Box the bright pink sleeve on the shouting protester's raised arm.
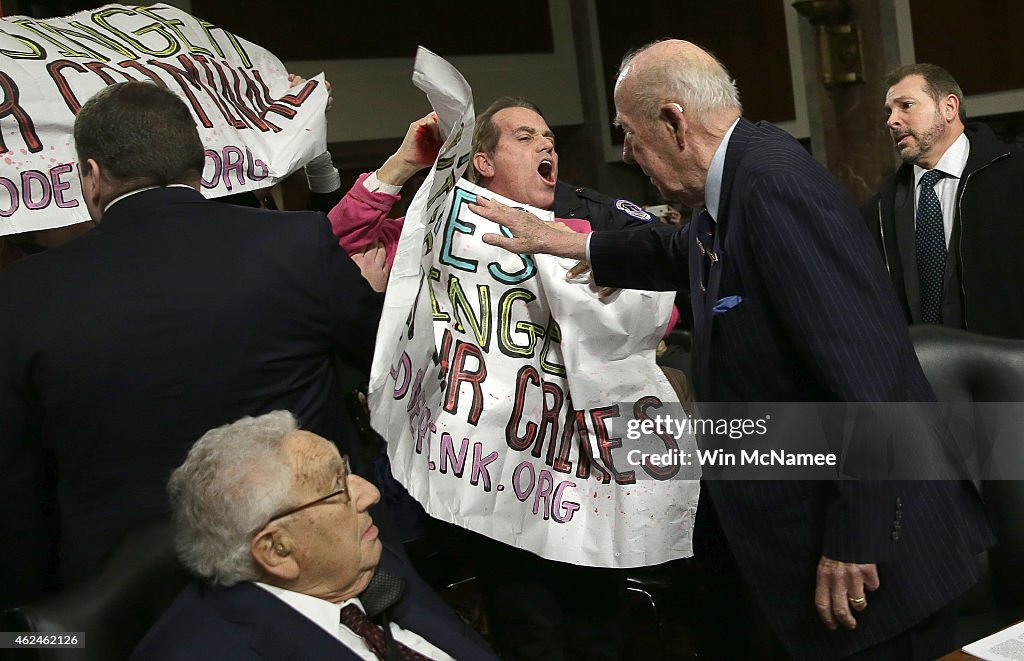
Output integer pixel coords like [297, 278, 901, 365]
[327, 172, 404, 267]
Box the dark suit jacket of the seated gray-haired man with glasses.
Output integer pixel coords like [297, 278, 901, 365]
[131, 545, 497, 661]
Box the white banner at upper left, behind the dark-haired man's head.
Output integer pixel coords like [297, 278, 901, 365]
[0, 4, 328, 235]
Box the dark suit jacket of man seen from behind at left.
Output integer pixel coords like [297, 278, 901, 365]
[0, 187, 382, 604]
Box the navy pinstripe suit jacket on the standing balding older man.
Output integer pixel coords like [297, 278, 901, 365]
[591, 120, 990, 659]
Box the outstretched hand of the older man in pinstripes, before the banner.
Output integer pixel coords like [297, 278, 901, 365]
[469, 196, 588, 261]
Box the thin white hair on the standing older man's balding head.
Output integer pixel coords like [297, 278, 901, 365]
[615, 40, 742, 121]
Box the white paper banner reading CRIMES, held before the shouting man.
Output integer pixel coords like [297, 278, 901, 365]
[370, 49, 699, 567]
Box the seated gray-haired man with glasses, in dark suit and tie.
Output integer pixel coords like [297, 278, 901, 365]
[132, 411, 495, 661]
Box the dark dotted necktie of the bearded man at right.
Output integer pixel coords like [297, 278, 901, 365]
[915, 170, 946, 323]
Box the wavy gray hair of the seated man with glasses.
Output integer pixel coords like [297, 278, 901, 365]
[167, 410, 298, 585]
